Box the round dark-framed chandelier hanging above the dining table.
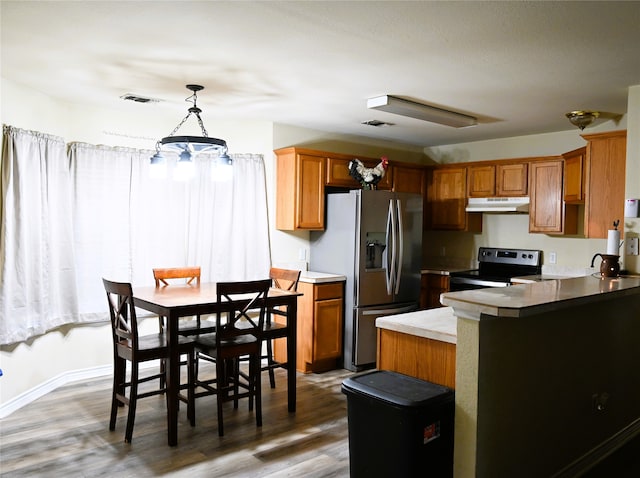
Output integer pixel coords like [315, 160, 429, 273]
[151, 85, 231, 165]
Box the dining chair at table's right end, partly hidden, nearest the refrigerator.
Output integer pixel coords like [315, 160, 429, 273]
[262, 267, 300, 388]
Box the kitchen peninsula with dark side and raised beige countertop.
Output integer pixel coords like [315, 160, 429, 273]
[440, 276, 640, 478]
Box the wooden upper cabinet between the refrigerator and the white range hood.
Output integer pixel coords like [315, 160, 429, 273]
[426, 167, 482, 231]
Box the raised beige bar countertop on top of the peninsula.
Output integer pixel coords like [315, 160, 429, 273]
[441, 275, 640, 320]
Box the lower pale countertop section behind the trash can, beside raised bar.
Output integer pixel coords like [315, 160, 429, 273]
[376, 307, 457, 344]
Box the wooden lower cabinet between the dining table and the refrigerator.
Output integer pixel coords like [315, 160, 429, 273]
[274, 282, 344, 373]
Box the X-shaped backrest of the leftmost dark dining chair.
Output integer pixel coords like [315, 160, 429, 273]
[102, 279, 138, 350]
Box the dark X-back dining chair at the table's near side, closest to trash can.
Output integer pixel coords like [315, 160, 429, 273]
[195, 279, 271, 436]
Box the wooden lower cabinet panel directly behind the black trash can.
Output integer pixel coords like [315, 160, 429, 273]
[377, 329, 456, 388]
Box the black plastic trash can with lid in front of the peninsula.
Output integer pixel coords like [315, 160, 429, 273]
[342, 370, 455, 478]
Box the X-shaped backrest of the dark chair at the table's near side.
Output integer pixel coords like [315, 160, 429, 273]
[216, 279, 271, 346]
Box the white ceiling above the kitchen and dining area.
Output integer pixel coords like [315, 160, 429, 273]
[0, 0, 640, 146]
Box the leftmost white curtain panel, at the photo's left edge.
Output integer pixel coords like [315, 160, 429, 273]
[0, 126, 78, 344]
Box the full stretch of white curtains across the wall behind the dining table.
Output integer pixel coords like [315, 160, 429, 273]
[0, 128, 271, 344]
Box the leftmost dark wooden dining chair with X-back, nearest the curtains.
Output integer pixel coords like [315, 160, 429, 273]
[102, 279, 195, 443]
